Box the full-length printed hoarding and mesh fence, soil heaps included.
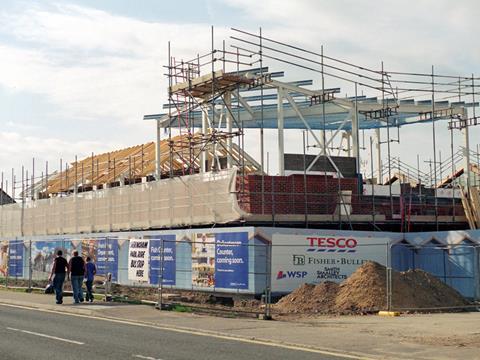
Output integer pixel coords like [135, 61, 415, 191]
[0, 238, 480, 319]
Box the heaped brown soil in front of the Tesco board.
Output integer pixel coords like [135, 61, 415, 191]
[275, 261, 469, 314]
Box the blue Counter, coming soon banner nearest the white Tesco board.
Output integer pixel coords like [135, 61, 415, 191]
[215, 232, 248, 289]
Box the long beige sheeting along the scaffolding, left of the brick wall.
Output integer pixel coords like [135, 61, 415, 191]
[0, 169, 244, 237]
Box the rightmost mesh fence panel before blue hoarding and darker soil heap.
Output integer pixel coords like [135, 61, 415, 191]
[388, 240, 480, 312]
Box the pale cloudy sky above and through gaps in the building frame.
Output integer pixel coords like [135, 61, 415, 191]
[0, 0, 480, 186]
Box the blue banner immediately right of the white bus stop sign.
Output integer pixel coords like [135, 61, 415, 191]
[149, 235, 177, 285]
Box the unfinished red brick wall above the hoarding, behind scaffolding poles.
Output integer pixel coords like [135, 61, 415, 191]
[237, 174, 464, 219]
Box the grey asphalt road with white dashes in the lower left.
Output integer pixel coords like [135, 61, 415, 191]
[0, 305, 344, 360]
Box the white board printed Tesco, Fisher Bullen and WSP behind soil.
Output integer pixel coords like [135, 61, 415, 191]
[271, 232, 389, 292]
